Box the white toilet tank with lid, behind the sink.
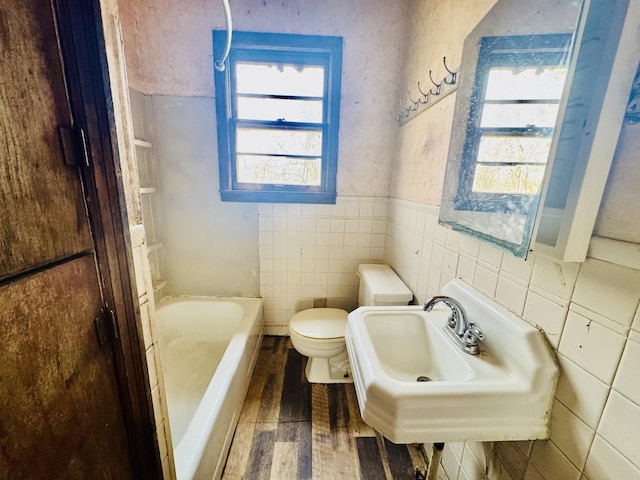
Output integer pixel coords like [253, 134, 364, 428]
[358, 264, 413, 306]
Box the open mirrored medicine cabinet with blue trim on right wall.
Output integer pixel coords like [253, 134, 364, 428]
[439, 0, 640, 262]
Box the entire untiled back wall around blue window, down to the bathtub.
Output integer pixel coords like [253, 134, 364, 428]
[118, 0, 408, 296]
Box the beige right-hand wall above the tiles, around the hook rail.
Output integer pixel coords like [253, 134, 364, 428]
[389, 0, 496, 205]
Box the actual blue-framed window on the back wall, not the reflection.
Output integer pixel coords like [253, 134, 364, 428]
[213, 30, 342, 203]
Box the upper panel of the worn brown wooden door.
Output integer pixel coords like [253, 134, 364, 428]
[0, 0, 92, 278]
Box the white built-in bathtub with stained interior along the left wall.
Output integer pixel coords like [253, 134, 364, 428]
[157, 297, 263, 480]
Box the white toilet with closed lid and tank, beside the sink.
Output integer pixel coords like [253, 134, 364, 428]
[289, 264, 413, 383]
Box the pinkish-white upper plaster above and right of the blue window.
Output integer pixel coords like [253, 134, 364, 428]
[118, 0, 408, 196]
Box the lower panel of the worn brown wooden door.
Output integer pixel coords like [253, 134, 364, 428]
[0, 255, 131, 479]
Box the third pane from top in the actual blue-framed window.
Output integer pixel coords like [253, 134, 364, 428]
[236, 128, 322, 157]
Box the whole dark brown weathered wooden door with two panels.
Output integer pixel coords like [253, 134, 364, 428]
[0, 0, 133, 479]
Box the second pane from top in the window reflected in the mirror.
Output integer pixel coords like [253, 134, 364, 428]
[480, 103, 558, 128]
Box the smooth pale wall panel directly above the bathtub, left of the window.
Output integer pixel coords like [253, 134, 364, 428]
[151, 95, 260, 297]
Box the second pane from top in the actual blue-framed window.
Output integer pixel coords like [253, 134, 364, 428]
[237, 97, 323, 123]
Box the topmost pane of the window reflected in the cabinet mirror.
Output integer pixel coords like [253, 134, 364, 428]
[484, 66, 567, 100]
